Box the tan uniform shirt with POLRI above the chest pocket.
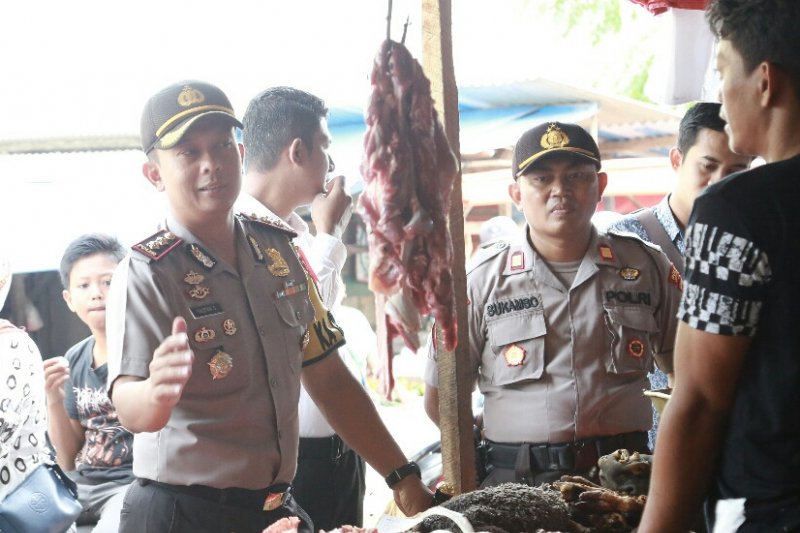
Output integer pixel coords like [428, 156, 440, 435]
[426, 229, 681, 444]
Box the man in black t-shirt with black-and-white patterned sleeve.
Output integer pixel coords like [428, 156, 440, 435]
[639, 0, 800, 532]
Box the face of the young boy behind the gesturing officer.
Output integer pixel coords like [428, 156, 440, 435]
[63, 253, 117, 334]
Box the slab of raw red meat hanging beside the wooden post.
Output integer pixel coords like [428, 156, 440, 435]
[359, 39, 458, 362]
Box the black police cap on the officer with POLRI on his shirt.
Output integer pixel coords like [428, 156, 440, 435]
[511, 122, 600, 179]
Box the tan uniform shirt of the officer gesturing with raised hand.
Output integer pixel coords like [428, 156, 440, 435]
[107, 214, 344, 489]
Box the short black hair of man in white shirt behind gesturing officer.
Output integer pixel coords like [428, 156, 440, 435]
[242, 87, 328, 172]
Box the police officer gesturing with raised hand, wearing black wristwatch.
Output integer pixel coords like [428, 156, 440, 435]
[107, 81, 431, 533]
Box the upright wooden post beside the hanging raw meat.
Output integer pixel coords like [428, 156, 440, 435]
[422, 0, 475, 494]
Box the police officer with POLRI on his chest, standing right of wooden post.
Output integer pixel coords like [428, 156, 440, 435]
[426, 122, 681, 486]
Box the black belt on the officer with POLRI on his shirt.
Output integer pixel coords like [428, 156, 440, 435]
[487, 431, 649, 472]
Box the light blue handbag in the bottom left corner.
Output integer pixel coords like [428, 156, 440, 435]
[0, 464, 81, 533]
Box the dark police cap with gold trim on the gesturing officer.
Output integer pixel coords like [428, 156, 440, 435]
[141, 80, 242, 153]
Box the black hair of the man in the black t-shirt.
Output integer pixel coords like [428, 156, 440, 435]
[706, 0, 800, 98]
